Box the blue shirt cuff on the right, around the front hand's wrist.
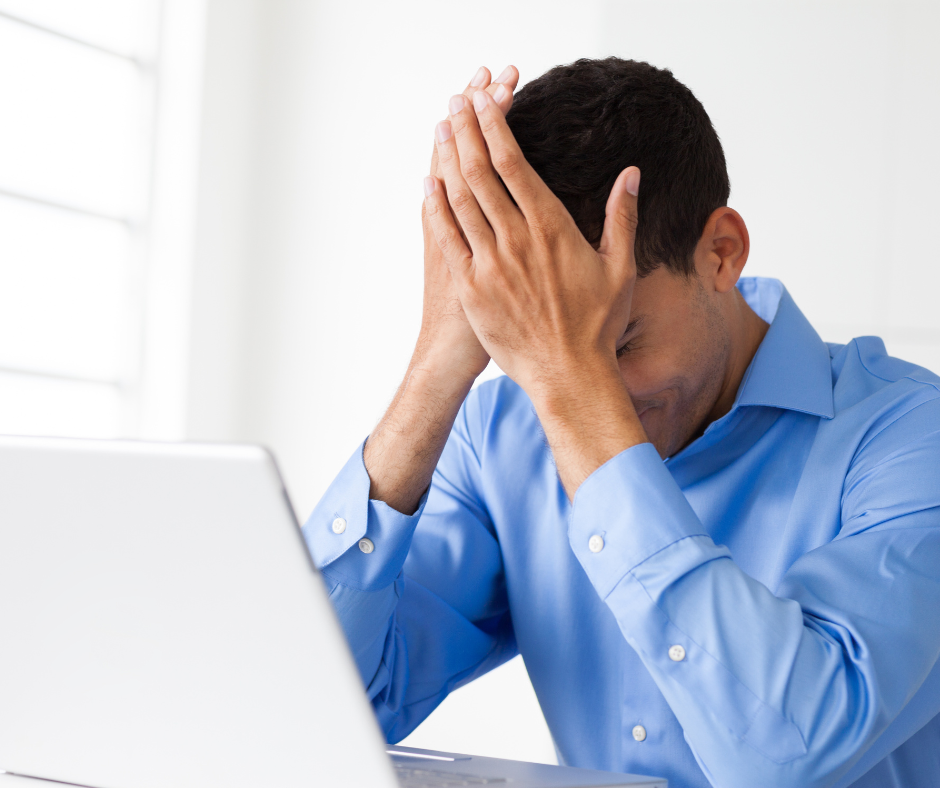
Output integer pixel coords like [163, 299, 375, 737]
[568, 443, 706, 599]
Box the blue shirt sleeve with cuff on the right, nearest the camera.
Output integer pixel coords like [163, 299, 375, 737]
[569, 400, 940, 788]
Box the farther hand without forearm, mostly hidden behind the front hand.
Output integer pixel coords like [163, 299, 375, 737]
[415, 66, 519, 383]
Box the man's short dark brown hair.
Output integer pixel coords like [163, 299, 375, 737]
[507, 57, 731, 276]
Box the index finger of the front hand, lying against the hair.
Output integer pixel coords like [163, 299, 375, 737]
[473, 86, 560, 218]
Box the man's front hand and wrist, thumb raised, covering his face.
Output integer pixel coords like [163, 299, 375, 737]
[425, 86, 647, 498]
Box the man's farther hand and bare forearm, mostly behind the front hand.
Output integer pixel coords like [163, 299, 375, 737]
[363, 66, 519, 514]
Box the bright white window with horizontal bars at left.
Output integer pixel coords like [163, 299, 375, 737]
[0, 0, 200, 438]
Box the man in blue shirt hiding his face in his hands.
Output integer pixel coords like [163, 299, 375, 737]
[304, 58, 940, 788]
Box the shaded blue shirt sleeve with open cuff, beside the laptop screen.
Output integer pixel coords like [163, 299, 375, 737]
[303, 392, 517, 742]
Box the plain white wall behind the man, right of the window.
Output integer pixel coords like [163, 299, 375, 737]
[189, 0, 940, 760]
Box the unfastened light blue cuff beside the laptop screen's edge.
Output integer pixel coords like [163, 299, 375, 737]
[302, 441, 428, 591]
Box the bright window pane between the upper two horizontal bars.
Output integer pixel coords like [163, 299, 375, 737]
[0, 16, 144, 216]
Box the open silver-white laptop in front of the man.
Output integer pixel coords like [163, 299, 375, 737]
[0, 437, 666, 788]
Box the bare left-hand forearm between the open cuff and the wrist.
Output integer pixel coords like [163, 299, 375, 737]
[364, 343, 474, 514]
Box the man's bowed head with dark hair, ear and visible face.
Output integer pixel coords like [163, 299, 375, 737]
[507, 58, 766, 456]
